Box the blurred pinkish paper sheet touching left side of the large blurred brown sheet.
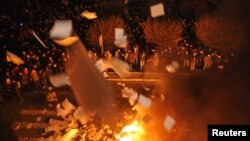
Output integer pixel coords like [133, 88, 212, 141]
[49, 73, 70, 87]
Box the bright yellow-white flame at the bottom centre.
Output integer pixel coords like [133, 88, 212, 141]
[116, 120, 144, 141]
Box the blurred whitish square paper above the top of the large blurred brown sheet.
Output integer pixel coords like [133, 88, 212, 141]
[50, 20, 73, 39]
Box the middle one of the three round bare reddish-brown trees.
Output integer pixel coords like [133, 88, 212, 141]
[141, 19, 183, 50]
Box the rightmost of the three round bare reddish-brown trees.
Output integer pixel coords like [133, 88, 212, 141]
[195, 15, 247, 51]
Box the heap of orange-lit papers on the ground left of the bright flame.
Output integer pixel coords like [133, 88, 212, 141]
[40, 99, 115, 141]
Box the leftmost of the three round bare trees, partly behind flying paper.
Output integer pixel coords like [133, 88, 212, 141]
[87, 16, 125, 50]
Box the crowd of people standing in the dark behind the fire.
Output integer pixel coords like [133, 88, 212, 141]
[0, 0, 232, 102]
